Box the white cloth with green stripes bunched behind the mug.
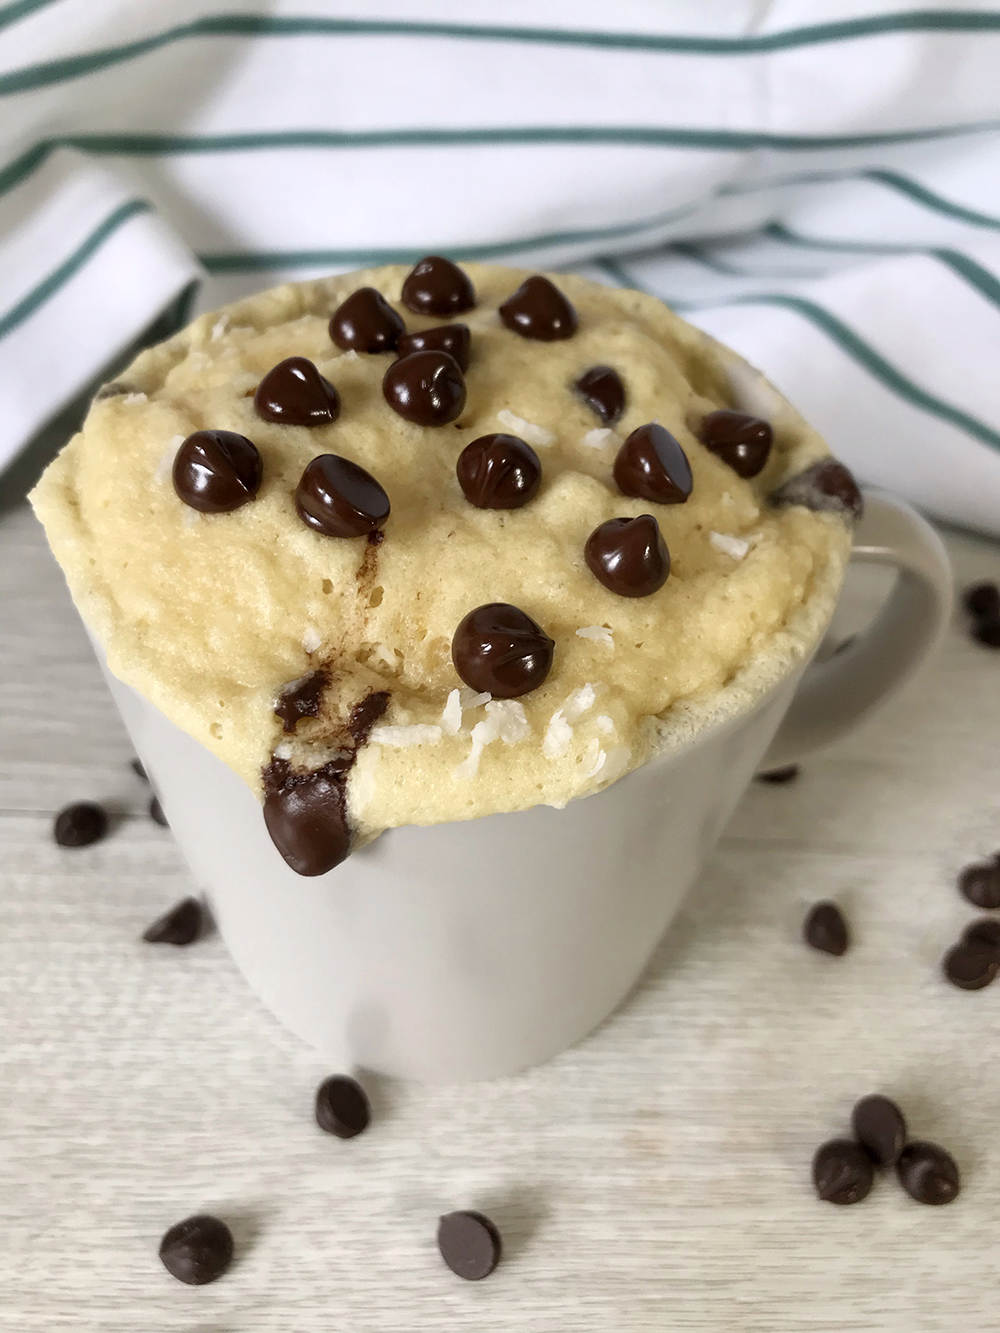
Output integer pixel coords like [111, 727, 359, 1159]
[0, 0, 1000, 535]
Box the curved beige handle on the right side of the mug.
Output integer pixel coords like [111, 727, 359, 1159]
[760, 491, 952, 772]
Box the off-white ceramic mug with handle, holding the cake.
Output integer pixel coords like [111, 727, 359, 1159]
[98, 495, 951, 1081]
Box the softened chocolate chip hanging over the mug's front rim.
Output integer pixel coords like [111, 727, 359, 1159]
[264, 760, 351, 876]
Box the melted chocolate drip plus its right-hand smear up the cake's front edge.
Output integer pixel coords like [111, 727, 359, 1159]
[263, 690, 389, 876]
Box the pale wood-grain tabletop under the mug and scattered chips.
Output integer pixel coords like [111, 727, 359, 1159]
[0, 508, 1000, 1333]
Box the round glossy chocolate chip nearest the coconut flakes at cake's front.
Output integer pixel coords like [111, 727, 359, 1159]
[452, 601, 556, 698]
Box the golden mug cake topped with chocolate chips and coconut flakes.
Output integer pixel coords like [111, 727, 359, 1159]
[32, 261, 855, 863]
